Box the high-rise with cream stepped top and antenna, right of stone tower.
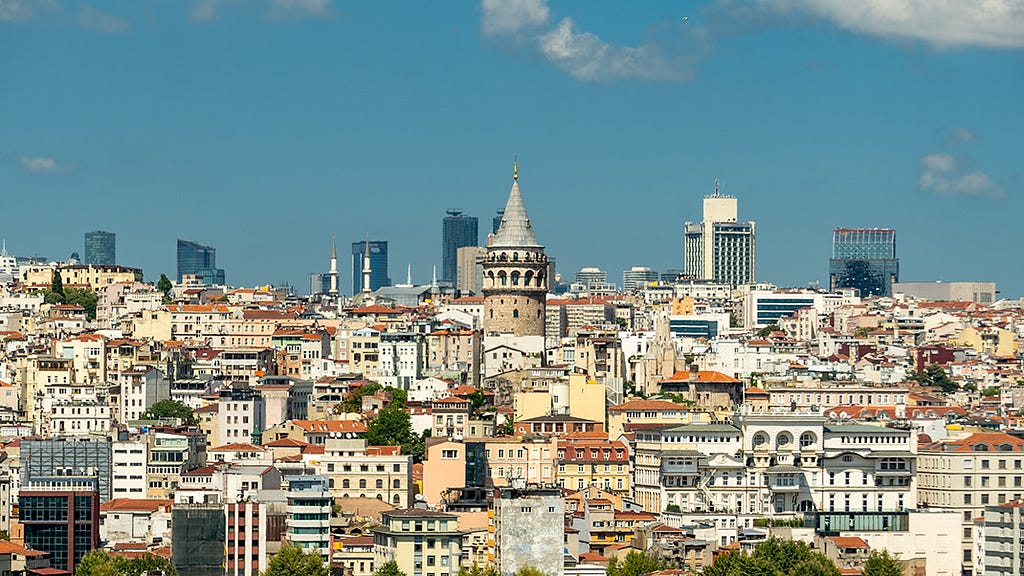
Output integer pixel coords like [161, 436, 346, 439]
[683, 178, 755, 287]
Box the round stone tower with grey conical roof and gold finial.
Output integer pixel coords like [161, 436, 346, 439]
[482, 158, 548, 337]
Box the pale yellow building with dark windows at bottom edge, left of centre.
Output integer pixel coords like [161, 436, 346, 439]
[374, 508, 463, 576]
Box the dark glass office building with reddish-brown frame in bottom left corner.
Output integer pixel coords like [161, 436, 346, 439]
[18, 476, 99, 574]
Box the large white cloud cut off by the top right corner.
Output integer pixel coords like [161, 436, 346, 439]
[759, 0, 1024, 48]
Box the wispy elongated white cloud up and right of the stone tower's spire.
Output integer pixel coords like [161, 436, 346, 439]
[539, 17, 688, 80]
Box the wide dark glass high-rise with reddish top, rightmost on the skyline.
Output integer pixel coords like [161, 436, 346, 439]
[828, 228, 899, 296]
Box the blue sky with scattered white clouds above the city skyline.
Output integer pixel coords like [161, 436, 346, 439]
[0, 0, 1024, 297]
